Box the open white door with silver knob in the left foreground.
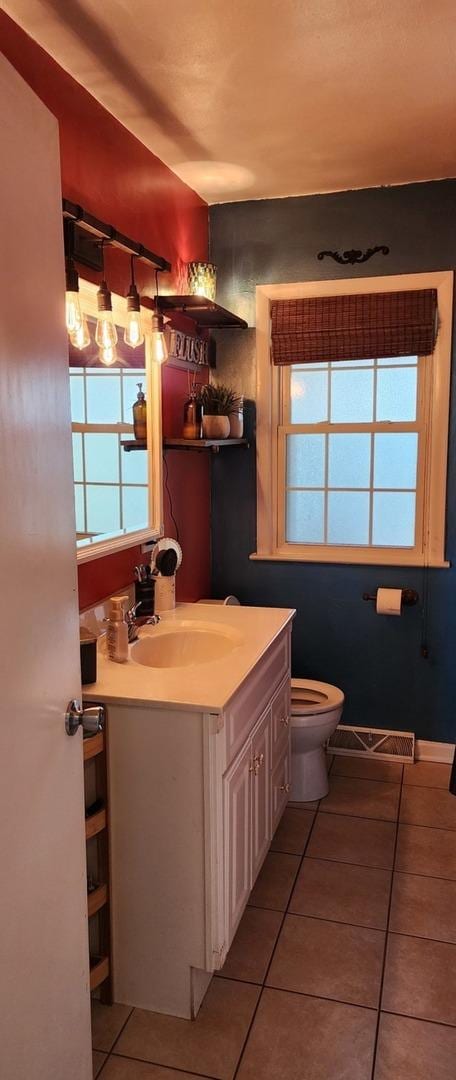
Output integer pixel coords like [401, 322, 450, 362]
[0, 56, 92, 1080]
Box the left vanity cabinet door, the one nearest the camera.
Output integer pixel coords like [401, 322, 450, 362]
[224, 742, 252, 946]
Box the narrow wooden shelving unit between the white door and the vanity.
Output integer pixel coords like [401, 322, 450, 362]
[82, 728, 112, 1004]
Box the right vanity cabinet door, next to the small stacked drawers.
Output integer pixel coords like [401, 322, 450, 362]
[251, 708, 271, 883]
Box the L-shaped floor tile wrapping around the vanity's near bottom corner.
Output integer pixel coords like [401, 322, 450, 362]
[116, 978, 260, 1080]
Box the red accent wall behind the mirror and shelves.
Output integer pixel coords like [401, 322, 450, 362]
[0, 11, 210, 608]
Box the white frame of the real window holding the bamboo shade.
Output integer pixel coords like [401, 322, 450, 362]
[250, 270, 453, 567]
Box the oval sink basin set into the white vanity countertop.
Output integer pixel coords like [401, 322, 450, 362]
[130, 623, 243, 667]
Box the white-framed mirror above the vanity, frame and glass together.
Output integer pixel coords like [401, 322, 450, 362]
[69, 282, 161, 561]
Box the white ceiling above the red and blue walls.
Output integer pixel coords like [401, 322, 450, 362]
[0, 0, 456, 202]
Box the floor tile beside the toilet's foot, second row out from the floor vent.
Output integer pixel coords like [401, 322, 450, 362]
[320, 777, 399, 821]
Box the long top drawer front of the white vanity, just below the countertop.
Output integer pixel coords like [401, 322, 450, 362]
[225, 629, 291, 766]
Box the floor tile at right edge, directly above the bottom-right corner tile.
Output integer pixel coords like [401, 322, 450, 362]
[381, 934, 456, 1025]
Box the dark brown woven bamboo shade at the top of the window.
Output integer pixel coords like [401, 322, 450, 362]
[271, 288, 437, 364]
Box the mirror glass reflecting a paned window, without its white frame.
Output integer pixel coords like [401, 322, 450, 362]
[69, 316, 149, 549]
